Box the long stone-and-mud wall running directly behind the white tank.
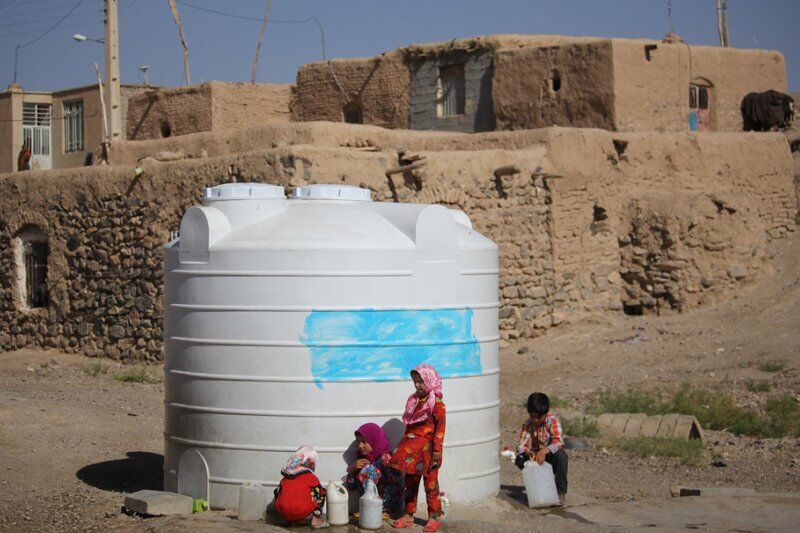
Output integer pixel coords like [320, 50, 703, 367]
[0, 123, 795, 359]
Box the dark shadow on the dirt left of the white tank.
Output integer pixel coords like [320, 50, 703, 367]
[75, 452, 164, 492]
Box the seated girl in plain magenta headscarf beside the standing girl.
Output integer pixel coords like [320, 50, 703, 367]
[344, 422, 403, 518]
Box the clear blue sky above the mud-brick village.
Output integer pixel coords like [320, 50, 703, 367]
[0, 0, 800, 91]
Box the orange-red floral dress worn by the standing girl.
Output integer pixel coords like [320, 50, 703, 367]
[389, 398, 446, 475]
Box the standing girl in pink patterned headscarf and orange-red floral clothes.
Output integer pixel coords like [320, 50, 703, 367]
[389, 364, 445, 532]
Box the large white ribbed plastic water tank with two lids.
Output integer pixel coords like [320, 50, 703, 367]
[164, 184, 500, 509]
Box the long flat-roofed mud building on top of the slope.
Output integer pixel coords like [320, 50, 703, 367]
[292, 35, 787, 132]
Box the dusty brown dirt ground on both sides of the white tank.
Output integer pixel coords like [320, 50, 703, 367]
[0, 233, 800, 531]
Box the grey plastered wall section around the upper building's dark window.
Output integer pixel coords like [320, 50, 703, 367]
[408, 50, 495, 132]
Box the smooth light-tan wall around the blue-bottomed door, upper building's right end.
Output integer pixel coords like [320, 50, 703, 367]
[611, 39, 787, 131]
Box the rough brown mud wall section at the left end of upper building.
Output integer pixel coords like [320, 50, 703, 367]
[291, 51, 410, 128]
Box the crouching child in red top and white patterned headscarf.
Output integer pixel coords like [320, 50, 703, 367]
[275, 446, 328, 529]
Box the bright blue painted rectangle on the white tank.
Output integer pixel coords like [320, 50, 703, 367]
[300, 309, 482, 386]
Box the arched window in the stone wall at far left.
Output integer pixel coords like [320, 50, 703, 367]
[16, 226, 50, 309]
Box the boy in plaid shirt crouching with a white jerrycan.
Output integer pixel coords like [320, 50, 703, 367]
[514, 392, 568, 506]
